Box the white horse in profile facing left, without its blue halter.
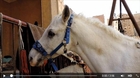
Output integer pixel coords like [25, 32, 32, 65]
[29, 5, 140, 73]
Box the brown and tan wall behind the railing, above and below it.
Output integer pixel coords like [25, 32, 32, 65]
[0, 0, 63, 56]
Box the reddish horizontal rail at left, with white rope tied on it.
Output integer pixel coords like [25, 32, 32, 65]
[3, 14, 27, 27]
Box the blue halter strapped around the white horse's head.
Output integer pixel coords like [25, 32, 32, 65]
[33, 14, 73, 71]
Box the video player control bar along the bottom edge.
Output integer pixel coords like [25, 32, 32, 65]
[2, 73, 140, 78]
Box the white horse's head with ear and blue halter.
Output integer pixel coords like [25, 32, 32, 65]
[29, 5, 73, 66]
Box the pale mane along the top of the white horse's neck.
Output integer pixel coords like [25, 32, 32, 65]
[74, 14, 138, 42]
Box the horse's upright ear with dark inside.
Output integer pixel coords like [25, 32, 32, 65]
[62, 5, 71, 23]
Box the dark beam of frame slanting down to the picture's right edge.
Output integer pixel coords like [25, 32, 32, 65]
[121, 0, 140, 36]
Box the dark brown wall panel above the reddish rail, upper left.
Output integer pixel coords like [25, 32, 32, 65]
[0, 0, 41, 24]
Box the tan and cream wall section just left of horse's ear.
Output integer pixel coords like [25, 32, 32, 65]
[41, 0, 64, 28]
